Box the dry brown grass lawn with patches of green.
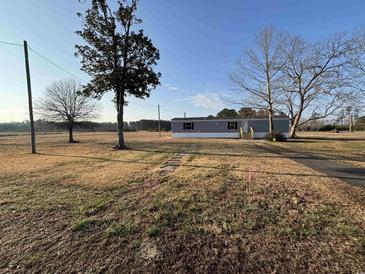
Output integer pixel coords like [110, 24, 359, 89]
[0, 132, 365, 272]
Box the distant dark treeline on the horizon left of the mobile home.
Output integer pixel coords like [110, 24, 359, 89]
[0, 119, 171, 132]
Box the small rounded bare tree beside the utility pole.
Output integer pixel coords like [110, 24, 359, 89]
[35, 79, 98, 143]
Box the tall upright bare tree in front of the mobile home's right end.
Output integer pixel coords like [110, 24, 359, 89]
[231, 26, 287, 132]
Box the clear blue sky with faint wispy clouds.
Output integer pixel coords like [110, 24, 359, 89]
[0, 0, 365, 122]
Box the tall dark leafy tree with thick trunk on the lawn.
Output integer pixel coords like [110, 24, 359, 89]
[76, 0, 161, 149]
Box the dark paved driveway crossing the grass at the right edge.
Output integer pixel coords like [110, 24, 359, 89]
[260, 144, 365, 188]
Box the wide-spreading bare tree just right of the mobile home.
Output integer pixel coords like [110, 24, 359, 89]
[282, 34, 354, 137]
